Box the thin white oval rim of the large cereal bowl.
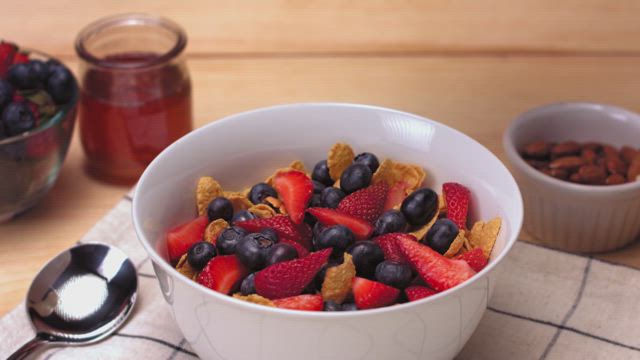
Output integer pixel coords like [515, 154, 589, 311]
[131, 102, 524, 318]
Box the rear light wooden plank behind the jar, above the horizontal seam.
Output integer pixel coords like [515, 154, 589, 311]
[0, 0, 640, 55]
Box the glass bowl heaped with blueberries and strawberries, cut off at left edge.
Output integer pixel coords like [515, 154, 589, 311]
[0, 41, 79, 222]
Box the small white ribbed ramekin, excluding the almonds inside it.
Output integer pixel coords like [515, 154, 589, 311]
[503, 103, 640, 253]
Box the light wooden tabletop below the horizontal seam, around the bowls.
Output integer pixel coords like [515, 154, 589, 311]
[0, 56, 640, 315]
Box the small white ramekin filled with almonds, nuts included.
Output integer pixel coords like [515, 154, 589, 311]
[503, 103, 640, 253]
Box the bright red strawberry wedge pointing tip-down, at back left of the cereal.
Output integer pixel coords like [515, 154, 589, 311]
[273, 170, 313, 224]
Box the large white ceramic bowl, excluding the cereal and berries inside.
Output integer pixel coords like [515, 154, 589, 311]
[133, 104, 522, 360]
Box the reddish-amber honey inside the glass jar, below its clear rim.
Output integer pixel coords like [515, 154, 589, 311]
[79, 53, 192, 183]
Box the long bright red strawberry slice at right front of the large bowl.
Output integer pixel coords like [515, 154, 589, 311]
[397, 239, 476, 292]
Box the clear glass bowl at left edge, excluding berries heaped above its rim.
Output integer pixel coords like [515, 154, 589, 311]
[0, 50, 79, 222]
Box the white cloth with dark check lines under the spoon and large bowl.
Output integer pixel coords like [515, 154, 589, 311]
[0, 196, 640, 360]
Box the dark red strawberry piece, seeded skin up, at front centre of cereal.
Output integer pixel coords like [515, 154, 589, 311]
[255, 248, 332, 300]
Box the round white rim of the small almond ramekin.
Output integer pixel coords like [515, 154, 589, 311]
[502, 102, 640, 195]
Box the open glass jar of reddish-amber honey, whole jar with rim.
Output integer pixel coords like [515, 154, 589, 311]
[76, 14, 192, 183]
